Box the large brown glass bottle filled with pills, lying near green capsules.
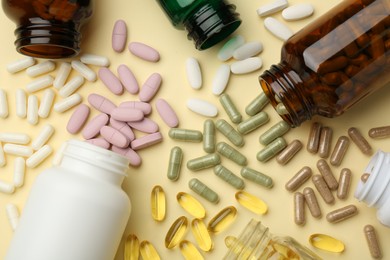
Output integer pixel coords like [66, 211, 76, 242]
[259, 0, 390, 127]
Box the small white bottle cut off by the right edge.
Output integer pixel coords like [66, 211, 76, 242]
[355, 151, 390, 227]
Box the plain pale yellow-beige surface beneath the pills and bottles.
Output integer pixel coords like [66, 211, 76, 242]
[0, 0, 390, 259]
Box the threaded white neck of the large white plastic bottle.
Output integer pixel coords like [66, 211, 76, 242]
[60, 140, 129, 186]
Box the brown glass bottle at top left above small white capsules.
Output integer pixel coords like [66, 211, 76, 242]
[2, 0, 93, 59]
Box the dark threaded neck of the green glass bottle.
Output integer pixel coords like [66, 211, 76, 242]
[184, 1, 241, 50]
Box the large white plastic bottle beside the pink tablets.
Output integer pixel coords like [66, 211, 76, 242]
[5, 140, 131, 260]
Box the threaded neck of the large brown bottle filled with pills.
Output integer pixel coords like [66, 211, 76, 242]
[259, 62, 316, 127]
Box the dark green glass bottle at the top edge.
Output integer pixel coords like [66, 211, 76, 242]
[157, 0, 241, 50]
